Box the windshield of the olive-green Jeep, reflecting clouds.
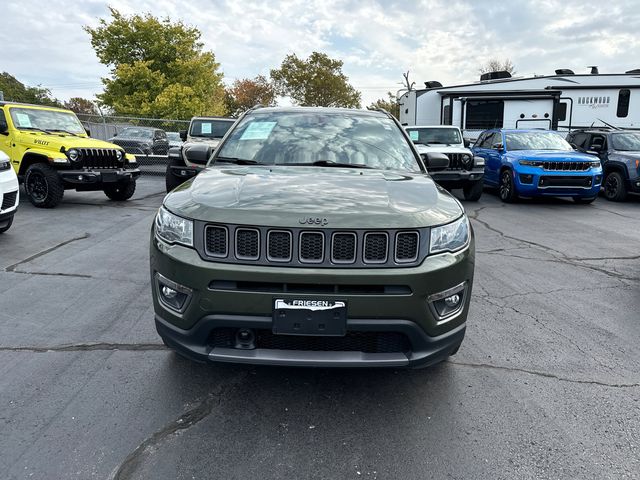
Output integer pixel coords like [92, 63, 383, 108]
[216, 111, 420, 172]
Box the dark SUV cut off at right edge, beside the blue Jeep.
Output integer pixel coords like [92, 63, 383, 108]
[567, 128, 640, 202]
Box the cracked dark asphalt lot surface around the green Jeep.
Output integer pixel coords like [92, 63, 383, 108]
[0, 178, 640, 479]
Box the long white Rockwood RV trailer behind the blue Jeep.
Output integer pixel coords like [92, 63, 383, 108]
[398, 69, 640, 138]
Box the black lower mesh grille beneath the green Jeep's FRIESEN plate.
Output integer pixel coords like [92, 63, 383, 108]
[210, 328, 411, 353]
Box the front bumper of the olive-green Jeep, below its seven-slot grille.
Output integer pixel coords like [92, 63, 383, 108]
[150, 230, 475, 367]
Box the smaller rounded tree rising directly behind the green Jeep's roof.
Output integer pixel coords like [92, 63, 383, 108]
[271, 52, 361, 108]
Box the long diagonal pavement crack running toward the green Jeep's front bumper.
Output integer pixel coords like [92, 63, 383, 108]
[108, 374, 248, 480]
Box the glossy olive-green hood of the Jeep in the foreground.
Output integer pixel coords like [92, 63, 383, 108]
[164, 165, 463, 228]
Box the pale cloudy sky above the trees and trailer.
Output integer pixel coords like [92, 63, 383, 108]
[0, 0, 640, 105]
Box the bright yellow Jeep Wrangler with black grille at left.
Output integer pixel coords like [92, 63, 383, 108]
[0, 102, 140, 208]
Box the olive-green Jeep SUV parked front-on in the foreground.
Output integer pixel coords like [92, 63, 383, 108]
[150, 108, 475, 367]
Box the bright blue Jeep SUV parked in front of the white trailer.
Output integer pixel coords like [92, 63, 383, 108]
[473, 129, 602, 203]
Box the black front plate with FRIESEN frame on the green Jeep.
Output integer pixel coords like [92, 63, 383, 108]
[273, 299, 347, 337]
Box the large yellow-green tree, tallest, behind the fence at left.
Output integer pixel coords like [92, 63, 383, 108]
[84, 8, 226, 119]
